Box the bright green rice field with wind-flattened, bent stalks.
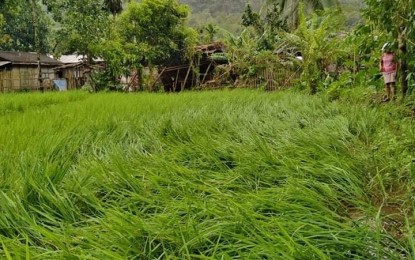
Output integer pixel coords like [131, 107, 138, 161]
[0, 90, 415, 259]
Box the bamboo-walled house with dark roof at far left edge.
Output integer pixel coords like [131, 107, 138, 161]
[0, 51, 62, 92]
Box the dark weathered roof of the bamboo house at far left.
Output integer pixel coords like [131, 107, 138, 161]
[0, 51, 61, 65]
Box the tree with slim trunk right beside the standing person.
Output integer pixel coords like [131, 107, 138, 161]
[363, 0, 415, 96]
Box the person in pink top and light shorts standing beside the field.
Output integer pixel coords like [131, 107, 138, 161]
[379, 43, 398, 102]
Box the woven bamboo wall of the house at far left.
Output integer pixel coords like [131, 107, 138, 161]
[0, 65, 55, 92]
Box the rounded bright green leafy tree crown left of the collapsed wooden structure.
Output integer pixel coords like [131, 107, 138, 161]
[118, 0, 196, 65]
